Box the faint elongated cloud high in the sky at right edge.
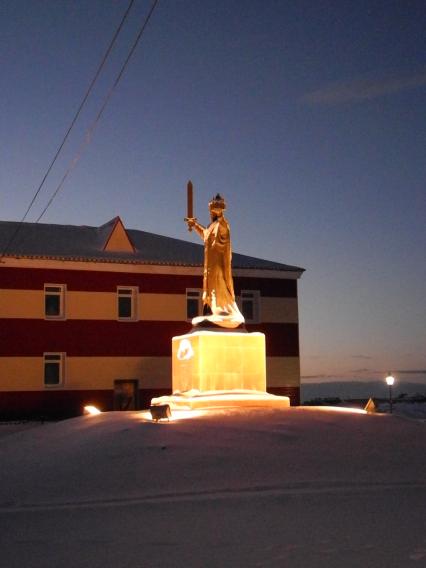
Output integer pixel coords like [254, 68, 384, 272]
[302, 72, 426, 105]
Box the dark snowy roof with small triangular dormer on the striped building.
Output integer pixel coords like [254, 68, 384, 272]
[0, 217, 304, 272]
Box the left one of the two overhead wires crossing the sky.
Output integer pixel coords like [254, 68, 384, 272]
[0, 0, 134, 259]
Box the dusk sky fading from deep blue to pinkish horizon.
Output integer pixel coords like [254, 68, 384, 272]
[0, 0, 426, 384]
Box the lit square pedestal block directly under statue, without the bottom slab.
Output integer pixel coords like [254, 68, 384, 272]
[172, 331, 266, 392]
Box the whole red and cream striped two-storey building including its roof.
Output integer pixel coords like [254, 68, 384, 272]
[0, 217, 303, 417]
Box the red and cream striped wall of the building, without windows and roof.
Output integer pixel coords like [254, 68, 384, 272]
[0, 259, 300, 416]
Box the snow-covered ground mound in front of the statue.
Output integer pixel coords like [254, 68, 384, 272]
[0, 407, 426, 568]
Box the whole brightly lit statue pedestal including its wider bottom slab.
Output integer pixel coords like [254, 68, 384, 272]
[151, 330, 290, 410]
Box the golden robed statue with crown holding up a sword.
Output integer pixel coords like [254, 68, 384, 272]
[185, 182, 244, 328]
